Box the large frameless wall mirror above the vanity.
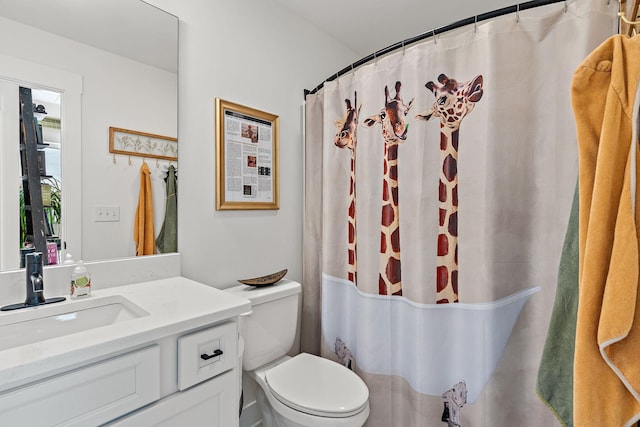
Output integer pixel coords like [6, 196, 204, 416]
[0, 0, 178, 271]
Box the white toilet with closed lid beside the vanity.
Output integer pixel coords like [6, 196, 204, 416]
[225, 279, 369, 427]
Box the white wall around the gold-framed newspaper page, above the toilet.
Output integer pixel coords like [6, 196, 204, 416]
[143, 0, 359, 287]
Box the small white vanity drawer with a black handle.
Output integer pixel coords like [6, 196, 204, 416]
[178, 322, 238, 390]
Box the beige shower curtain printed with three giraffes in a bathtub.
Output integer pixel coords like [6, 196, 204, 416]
[301, 0, 617, 427]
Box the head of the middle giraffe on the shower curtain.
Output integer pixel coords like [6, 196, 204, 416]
[363, 82, 413, 144]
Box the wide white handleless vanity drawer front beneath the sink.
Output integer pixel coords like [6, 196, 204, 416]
[0, 345, 160, 427]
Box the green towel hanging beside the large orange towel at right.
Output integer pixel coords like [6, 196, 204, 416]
[536, 183, 579, 427]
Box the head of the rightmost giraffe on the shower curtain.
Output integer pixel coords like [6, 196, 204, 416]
[416, 74, 482, 129]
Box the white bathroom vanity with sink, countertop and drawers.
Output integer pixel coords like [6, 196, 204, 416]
[0, 277, 250, 427]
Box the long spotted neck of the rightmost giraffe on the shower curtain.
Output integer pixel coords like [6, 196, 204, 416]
[436, 126, 459, 304]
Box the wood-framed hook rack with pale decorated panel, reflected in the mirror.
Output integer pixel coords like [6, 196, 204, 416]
[109, 127, 178, 161]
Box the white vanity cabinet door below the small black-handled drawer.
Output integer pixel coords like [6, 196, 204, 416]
[108, 370, 238, 427]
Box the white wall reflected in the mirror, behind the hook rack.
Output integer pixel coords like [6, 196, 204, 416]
[0, 17, 177, 260]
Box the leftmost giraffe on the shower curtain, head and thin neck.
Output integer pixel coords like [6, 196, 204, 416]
[334, 92, 362, 286]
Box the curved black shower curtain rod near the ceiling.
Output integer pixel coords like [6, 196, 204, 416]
[304, 0, 567, 99]
